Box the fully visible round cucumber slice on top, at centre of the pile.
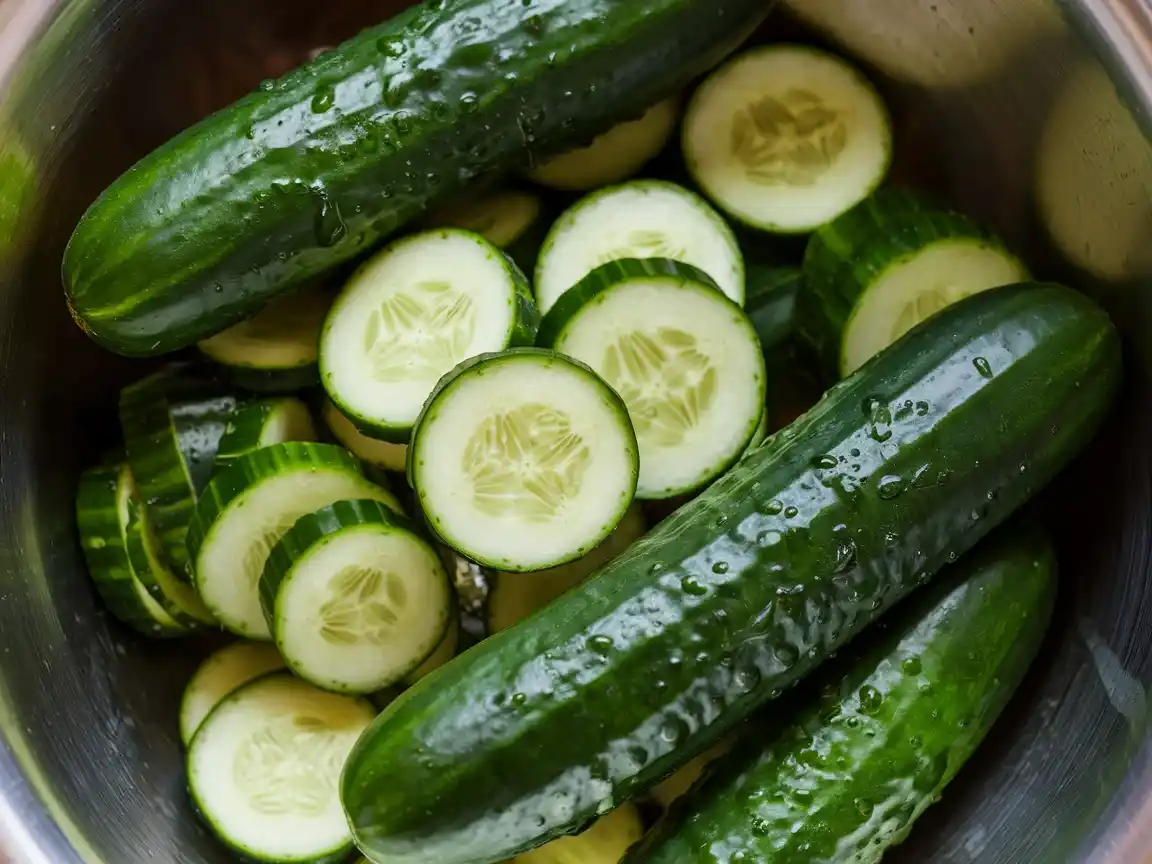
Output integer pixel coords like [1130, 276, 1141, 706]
[408, 348, 638, 571]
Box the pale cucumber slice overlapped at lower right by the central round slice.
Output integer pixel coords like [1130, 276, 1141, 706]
[320, 229, 538, 444]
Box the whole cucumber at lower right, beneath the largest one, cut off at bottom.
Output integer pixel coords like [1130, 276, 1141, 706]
[626, 524, 1056, 864]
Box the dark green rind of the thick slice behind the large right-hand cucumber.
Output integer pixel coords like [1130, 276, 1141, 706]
[796, 188, 1022, 380]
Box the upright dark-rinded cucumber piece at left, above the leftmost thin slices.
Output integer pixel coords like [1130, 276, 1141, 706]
[120, 370, 236, 577]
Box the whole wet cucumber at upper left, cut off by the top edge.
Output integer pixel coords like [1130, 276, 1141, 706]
[63, 0, 772, 355]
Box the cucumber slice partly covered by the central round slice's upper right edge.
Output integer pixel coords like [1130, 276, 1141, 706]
[540, 258, 765, 499]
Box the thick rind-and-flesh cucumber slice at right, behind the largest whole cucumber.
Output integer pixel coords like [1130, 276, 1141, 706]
[797, 190, 1028, 377]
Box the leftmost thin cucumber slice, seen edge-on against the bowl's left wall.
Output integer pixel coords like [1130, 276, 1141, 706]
[76, 464, 189, 637]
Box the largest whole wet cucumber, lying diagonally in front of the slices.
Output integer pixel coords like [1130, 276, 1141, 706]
[342, 283, 1121, 864]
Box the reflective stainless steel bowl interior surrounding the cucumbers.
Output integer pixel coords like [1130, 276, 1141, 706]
[0, 0, 1152, 864]
